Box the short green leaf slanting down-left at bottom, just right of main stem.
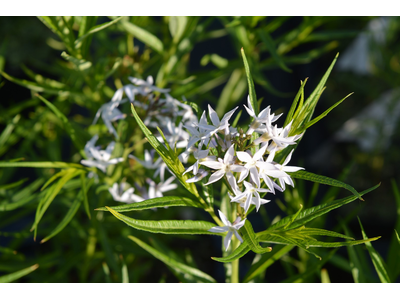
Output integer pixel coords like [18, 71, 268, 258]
[243, 245, 294, 282]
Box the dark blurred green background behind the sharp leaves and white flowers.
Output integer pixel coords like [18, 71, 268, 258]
[0, 17, 400, 282]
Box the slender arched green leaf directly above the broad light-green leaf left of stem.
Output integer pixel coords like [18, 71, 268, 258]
[96, 196, 203, 212]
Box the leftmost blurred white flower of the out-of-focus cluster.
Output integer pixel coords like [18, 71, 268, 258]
[81, 136, 124, 173]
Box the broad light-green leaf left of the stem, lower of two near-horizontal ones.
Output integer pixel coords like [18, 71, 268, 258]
[106, 206, 225, 236]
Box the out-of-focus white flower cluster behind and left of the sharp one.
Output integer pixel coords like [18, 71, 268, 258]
[81, 76, 197, 203]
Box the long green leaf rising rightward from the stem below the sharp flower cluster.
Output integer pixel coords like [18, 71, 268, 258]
[257, 184, 380, 233]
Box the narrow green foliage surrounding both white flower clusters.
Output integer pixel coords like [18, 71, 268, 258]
[0, 16, 390, 283]
